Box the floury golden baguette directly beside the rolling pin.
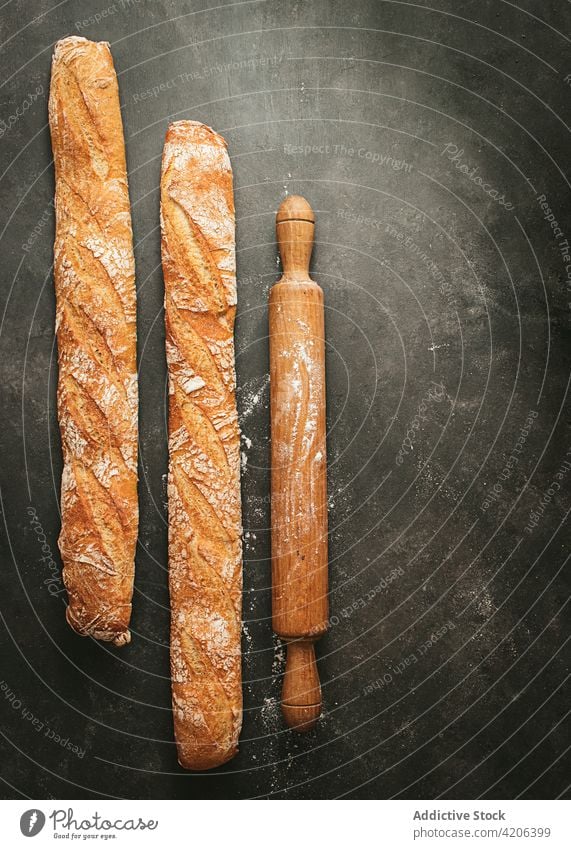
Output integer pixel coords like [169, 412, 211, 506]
[161, 121, 242, 770]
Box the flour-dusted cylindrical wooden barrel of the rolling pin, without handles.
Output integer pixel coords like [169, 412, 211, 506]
[269, 279, 328, 639]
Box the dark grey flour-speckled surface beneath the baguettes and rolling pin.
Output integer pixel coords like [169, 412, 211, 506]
[0, 0, 571, 798]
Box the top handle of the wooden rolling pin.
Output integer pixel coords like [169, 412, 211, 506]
[276, 195, 315, 281]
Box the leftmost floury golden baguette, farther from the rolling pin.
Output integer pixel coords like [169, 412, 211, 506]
[49, 37, 138, 645]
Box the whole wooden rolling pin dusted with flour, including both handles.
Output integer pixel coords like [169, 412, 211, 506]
[269, 195, 329, 731]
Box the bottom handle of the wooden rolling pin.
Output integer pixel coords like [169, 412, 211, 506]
[282, 640, 321, 731]
